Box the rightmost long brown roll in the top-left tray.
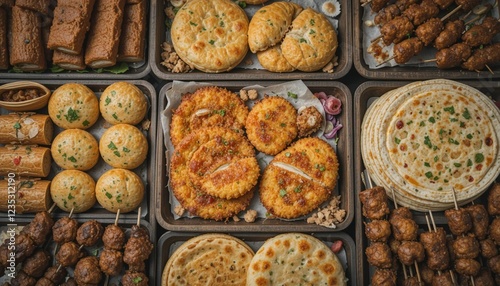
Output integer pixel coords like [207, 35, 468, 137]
[118, 0, 147, 62]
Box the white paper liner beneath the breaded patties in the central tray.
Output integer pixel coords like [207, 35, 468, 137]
[160, 80, 338, 220]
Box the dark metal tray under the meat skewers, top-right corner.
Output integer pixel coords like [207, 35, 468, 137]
[352, 0, 500, 80]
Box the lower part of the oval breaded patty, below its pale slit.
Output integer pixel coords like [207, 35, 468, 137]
[259, 164, 331, 219]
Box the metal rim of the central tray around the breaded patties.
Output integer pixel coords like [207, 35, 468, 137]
[155, 81, 354, 232]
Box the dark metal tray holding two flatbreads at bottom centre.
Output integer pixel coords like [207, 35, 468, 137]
[156, 231, 361, 286]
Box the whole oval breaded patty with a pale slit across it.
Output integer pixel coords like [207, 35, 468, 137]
[259, 138, 339, 219]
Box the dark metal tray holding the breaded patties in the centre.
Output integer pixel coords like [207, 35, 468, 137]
[155, 81, 354, 232]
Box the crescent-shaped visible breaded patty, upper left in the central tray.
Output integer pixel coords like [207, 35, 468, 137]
[170, 86, 248, 147]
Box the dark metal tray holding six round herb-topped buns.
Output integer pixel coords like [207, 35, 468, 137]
[0, 80, 157, 221]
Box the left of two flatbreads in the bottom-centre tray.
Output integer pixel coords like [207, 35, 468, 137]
[161, 234, 254, 286]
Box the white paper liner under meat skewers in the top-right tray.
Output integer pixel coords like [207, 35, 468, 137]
[361, 0, 499, 69]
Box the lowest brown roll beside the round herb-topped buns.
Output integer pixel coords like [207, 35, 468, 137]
[0, 178, 52, 214]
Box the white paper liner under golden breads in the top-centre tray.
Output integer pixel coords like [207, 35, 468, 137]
[166, 0, 343, 70]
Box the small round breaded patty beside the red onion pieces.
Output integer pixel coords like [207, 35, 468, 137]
[245, 96, 297, 155]
